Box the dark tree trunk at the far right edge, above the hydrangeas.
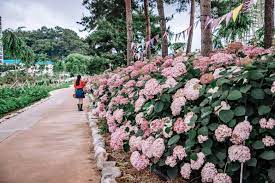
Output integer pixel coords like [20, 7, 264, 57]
[264, 0, 274, 49]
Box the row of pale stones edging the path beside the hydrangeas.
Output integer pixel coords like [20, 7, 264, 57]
[88, 94, 121, 183]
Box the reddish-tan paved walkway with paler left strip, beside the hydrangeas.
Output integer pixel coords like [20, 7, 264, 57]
[0, 88, 100, 183]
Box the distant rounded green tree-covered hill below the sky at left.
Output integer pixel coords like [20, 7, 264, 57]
[3, 26, 87, 60]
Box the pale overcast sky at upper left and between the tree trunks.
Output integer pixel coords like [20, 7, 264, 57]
[0, 0, 200, 49]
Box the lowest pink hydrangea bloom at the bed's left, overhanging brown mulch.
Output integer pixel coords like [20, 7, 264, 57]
[130, 151, 150, 171]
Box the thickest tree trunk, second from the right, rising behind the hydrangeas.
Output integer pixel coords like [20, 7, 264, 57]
[201, 0, 212, 56]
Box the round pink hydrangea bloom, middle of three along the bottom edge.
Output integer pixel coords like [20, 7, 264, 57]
[201, 163, 218, 182]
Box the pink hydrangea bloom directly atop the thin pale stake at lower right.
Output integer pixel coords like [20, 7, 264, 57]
[228, 145, 251, 163]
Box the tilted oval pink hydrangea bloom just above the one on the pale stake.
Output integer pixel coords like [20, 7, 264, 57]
[230, 120, 252, 144]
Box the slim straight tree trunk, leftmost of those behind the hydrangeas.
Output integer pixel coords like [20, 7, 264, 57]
[125, 0, 133, 65]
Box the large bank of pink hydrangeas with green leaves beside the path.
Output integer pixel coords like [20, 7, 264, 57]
[90, 44, 275, 183]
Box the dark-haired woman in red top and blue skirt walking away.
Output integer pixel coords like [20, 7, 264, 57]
[74, 75, 86, 111]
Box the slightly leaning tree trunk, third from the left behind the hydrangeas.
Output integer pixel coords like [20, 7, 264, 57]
[157, 0, 168, 57]
